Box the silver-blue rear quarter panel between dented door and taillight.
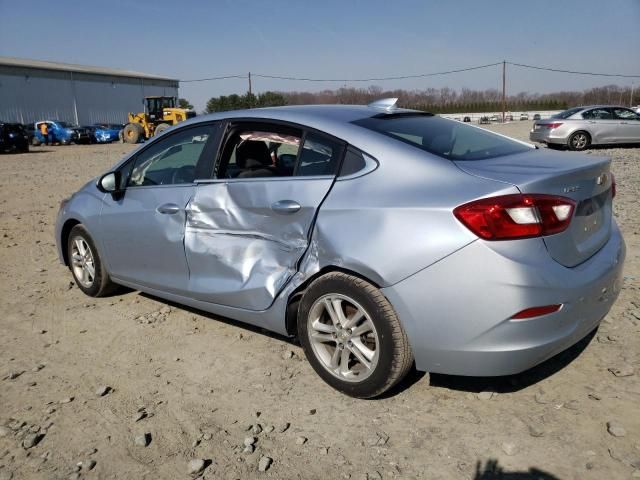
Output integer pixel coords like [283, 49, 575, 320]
[308, 140, 517, 286]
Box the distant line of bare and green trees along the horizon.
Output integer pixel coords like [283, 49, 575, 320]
[200, 85, 640, 113]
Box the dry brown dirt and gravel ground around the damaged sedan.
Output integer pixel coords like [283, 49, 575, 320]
[0, 122, 640, 480]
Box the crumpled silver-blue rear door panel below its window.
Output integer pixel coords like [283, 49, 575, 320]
[185, 177, 333, 310]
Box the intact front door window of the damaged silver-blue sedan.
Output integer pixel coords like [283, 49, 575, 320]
[128, 125, 213, 187]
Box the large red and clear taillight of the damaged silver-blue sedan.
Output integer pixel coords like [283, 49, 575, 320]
[453, 194, 576, 240]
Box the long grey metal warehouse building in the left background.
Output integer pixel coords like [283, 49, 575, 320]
[0, 57, 178, 125]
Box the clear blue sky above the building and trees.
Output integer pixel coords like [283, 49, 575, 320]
[0, 0, 640, 110]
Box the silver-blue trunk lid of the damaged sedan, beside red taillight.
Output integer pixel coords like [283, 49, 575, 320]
[455, 149, 612, 267]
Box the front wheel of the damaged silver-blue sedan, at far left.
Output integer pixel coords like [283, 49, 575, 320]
[67, 224, 116, 297]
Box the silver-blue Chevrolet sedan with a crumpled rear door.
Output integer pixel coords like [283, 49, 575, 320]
[55, 100, 625, 397]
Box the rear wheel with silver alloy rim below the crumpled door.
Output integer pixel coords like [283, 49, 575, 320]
[298, 272, 413, 398]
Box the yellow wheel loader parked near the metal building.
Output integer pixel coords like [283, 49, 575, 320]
[123, 97, 196, 143]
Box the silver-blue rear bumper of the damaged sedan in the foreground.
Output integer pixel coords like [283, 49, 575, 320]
[382, 222, 625, 376]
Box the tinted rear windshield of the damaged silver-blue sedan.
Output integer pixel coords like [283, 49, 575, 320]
[353, 114, 531, 160]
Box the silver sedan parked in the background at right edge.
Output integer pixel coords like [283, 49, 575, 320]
[529, 105, 640, 150]
